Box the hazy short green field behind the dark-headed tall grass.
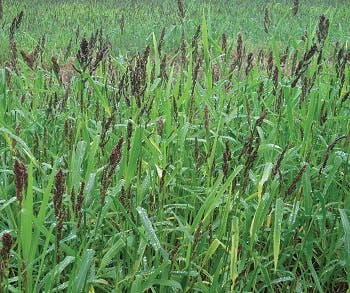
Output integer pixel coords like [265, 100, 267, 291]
[1, 0, 350, 55]
